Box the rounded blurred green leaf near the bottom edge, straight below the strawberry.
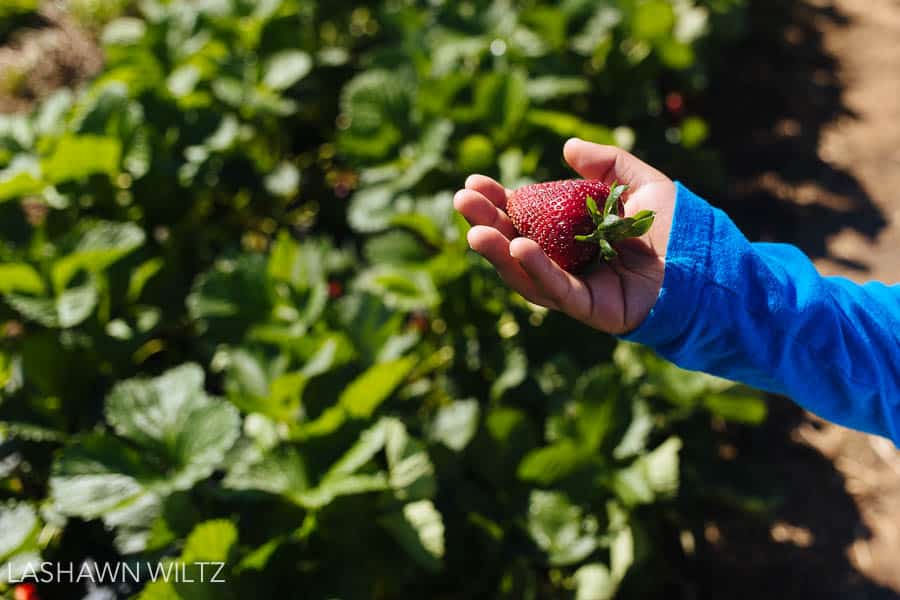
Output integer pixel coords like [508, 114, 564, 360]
[528, 490, 600, 566]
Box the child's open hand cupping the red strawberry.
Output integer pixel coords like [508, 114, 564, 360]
[453, 139, 675, 334]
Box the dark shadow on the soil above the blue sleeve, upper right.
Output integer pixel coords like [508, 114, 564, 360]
[705, 0, 886, 271]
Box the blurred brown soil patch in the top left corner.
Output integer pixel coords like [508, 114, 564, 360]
[0, 2, 103, 113]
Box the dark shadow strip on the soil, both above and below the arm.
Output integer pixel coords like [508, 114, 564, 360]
[691, 0, 900, 600]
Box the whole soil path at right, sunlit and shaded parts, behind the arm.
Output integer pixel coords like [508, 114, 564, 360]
[698, 0, 900, 600]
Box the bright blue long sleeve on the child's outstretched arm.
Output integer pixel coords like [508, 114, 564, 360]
[623, 184, 900, 445]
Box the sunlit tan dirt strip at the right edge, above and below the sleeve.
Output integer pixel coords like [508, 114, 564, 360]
[796, 0, 900, 595]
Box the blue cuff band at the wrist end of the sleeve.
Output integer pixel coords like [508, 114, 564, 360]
[619, 182, 714, 349]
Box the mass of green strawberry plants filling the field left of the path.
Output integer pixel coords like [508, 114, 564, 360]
[0, 0, 765, 599]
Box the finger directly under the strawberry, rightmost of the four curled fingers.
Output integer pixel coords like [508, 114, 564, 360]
[509, 238, 593, 321]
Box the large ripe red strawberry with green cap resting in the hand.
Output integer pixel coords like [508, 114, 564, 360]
[506, 179, 656, 273]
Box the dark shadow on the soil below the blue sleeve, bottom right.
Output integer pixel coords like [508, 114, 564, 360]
[690, 398, 900, 600]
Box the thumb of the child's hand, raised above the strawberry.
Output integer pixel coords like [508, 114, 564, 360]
[563, 138, 665, 188]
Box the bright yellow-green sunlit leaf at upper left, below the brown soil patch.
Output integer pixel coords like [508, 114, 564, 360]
[41, 135, 122, 183]
